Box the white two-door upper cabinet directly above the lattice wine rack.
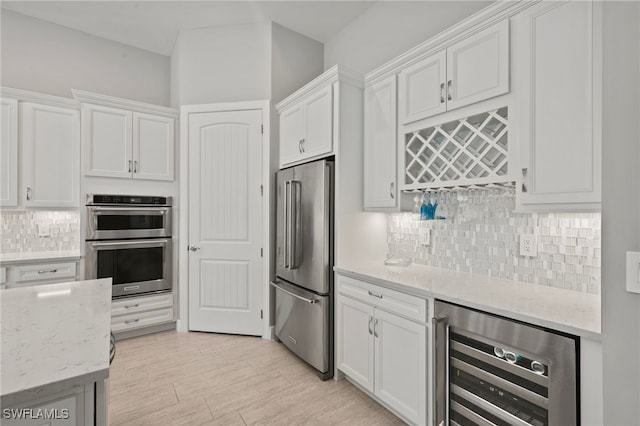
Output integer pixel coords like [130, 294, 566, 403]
[399, 19, 509, 124]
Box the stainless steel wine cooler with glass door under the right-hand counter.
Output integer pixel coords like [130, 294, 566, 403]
[433, 301, 580, 426]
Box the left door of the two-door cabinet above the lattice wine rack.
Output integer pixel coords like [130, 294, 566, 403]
[398, 50, 447, 124]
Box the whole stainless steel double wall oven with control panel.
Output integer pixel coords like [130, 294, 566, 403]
[86, 194, 172, 298]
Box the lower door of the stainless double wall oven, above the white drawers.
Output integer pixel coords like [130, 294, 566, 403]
[86, 238, 172, 298]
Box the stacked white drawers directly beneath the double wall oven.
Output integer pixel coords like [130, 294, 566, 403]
[111, 293, 174, 333]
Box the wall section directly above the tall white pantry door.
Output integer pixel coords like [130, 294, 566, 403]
[171, 23, 271, 106]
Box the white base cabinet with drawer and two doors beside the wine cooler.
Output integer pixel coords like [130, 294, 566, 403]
[337, 275, 427, 425]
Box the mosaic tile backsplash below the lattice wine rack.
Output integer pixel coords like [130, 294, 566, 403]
[387, 189, 601, 294]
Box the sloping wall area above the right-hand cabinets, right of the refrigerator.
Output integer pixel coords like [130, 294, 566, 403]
[324, 1, 492, 74]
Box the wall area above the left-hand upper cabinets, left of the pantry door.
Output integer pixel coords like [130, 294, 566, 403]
[1, 9, 170, 106]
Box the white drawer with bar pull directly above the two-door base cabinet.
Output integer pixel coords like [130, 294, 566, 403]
[337, 276, 428, 322]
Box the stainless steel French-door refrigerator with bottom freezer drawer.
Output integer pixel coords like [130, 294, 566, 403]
[271, 160, 334, 380]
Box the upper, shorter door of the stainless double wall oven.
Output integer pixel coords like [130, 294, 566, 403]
[86, 206, 171, 240]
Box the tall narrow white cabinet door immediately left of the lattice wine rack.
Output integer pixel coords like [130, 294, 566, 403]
[364, 75, 398, 210]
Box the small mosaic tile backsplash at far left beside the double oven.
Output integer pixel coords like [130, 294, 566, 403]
[0, 210, 80, 253]
